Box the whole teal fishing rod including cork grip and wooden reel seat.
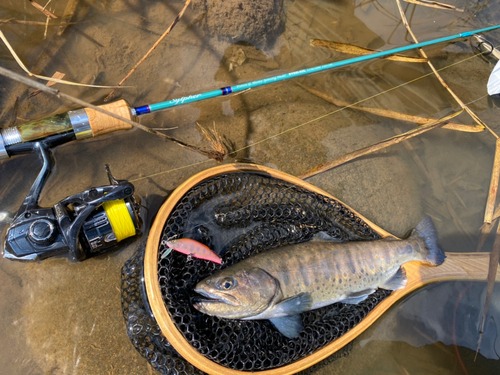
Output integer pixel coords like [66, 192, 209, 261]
[0, 25, 500, 160]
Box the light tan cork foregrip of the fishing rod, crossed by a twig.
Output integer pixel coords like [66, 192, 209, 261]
[85, 99, 134, 137]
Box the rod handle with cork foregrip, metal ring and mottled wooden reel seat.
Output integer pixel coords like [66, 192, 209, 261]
[0, 99, 135, 160]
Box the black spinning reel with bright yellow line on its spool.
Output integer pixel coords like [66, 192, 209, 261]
[3, 134, 142, 261]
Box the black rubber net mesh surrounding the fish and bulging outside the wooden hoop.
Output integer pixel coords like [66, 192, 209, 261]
[122, 172, 390, 374]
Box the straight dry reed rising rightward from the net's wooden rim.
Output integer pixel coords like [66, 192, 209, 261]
[299, 110, 463, 179]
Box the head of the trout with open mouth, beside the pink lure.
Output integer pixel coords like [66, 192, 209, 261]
[193, 267, 281, 319]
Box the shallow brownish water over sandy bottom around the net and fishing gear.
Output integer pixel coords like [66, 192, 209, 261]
[0, 0, 500, 374]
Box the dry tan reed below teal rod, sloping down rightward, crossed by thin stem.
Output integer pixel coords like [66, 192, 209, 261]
[296, 82, 484, 133]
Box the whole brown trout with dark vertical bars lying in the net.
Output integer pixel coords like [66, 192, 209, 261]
[193, 216, 446, 338]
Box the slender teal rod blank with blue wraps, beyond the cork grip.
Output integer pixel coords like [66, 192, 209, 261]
[134, 25, 500, 115]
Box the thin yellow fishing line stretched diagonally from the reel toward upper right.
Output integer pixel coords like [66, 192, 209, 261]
[130, 46, 498, 182]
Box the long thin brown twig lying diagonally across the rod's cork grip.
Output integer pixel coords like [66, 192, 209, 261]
[0, 66, 225, 160]
